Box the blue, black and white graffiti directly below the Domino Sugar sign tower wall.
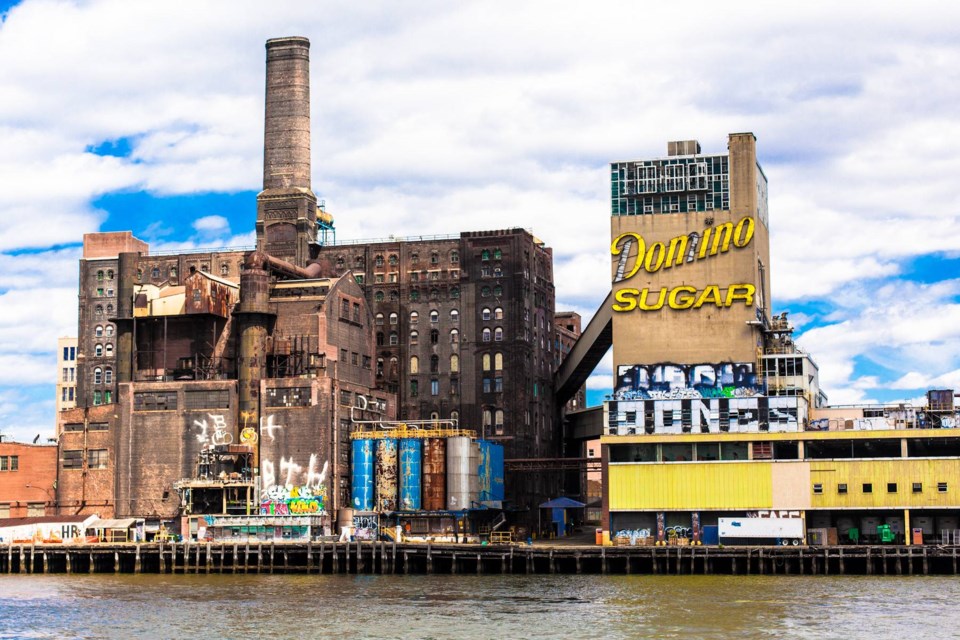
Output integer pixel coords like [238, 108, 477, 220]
[614, 362, 763, 400]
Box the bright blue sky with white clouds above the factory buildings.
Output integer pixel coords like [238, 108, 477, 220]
[0, 0, 960, 441]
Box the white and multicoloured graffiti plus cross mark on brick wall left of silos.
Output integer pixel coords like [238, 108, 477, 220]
[260, 415, 329, 516]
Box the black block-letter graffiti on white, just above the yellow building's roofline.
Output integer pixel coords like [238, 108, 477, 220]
[604, 396, 806, 436]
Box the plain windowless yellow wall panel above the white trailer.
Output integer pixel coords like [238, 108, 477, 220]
[609, 462, 773, 511]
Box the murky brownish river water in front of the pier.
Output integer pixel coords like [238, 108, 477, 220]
[0, 575, 960, 640]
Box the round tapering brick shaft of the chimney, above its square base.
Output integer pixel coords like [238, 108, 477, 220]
[263, 37, 310, 191]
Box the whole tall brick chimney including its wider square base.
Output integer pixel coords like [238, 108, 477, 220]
[257, 37, 317, 267]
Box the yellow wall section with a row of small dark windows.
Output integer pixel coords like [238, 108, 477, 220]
[808, 458, 960, 509]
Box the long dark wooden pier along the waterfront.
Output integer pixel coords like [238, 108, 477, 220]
[0, 542, 958, 576]
